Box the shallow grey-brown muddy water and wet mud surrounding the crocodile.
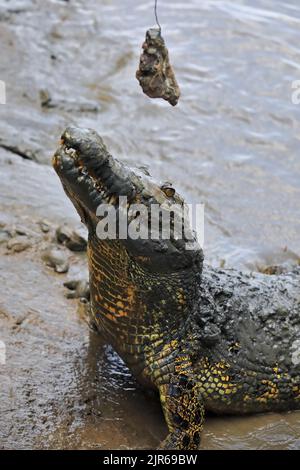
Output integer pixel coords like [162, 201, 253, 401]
[0, 0, 300, 449]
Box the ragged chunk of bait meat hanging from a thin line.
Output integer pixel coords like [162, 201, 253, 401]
[136, 28, 180, 106]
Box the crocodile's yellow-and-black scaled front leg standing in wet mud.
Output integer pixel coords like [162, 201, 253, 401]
[159, 375, 205, 450]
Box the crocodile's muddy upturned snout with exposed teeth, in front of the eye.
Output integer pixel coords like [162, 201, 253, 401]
[53, 127, 136, 212]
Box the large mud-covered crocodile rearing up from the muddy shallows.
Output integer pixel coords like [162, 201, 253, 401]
[53, 127, 300, 449]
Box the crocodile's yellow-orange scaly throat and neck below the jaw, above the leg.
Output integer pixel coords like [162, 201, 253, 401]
[88, 234, 199, 375]
